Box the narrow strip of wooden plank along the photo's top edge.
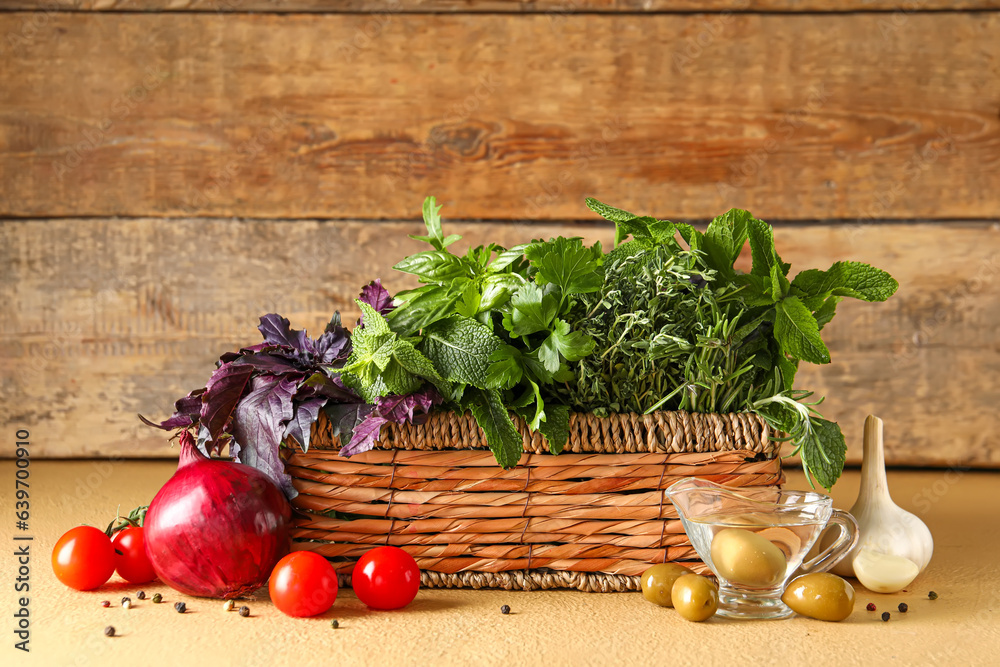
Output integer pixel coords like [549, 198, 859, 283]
[0, 0, 1000, 15]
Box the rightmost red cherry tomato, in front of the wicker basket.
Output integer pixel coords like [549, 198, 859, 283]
[351, 547, 420, 609]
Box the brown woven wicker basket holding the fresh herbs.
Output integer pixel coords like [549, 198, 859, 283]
[287, 412, 783, 592]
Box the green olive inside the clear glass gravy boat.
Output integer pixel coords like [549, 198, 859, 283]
[712, 528, 788, 587]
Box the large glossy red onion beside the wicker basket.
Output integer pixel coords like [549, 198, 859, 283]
[143, 431, 292, 599]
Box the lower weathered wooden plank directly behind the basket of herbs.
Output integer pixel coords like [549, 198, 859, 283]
[0, 219, 1000, 467]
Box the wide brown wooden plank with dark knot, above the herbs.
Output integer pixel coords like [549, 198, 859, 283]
[0, 13, 1000, 220]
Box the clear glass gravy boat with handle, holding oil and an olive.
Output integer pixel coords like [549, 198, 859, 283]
[665, 478, 858, 619]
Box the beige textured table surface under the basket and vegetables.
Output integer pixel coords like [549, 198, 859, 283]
[0, 461, 1000, 667]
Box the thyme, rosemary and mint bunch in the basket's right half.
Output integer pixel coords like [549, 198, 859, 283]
[563, 199, 898, 488]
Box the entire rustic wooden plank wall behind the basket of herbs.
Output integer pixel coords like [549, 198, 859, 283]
[0, 0, 1000, 467]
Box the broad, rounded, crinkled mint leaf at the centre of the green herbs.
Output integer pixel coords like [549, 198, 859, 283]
[422, 317, 503, 389]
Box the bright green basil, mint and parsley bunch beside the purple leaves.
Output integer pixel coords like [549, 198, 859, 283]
[340, 197, 604, 467]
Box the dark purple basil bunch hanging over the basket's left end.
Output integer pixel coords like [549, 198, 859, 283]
[139, 280, 441, 498]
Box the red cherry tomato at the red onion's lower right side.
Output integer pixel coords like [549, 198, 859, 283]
[267, 551, 337, 618]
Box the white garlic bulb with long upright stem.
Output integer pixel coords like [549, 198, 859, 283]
[833, 415, 934, 593]
